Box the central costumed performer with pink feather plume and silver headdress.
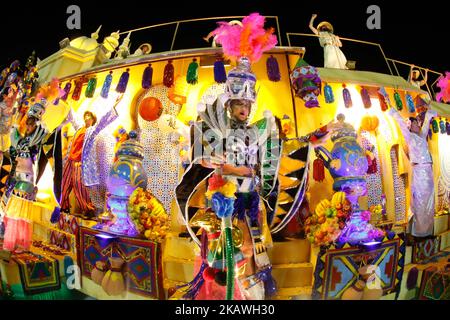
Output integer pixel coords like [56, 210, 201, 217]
[176, 14, 279, 300]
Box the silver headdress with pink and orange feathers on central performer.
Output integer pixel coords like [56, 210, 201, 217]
[208, 13, 277, 102]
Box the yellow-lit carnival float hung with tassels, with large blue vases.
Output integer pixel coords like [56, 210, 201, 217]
[0, 13, 450, 300]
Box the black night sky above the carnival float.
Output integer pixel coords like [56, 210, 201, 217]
[0, 0, 450, 82]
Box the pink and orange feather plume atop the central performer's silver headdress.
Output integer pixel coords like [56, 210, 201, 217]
[208, 13, 277, 63]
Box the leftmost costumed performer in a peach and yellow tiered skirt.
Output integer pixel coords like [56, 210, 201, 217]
[2, 80, 66, 251]
